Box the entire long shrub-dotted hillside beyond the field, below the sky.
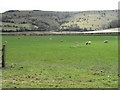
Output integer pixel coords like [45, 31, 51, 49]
[0, 10, 118, 31]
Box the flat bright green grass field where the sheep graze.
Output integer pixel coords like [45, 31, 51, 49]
[3, 36, 118, 88]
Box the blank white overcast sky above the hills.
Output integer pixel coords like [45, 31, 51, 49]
[0, 0, 119, 13]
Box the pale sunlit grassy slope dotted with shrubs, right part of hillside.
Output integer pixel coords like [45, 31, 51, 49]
[63, 11, 117, 30]
